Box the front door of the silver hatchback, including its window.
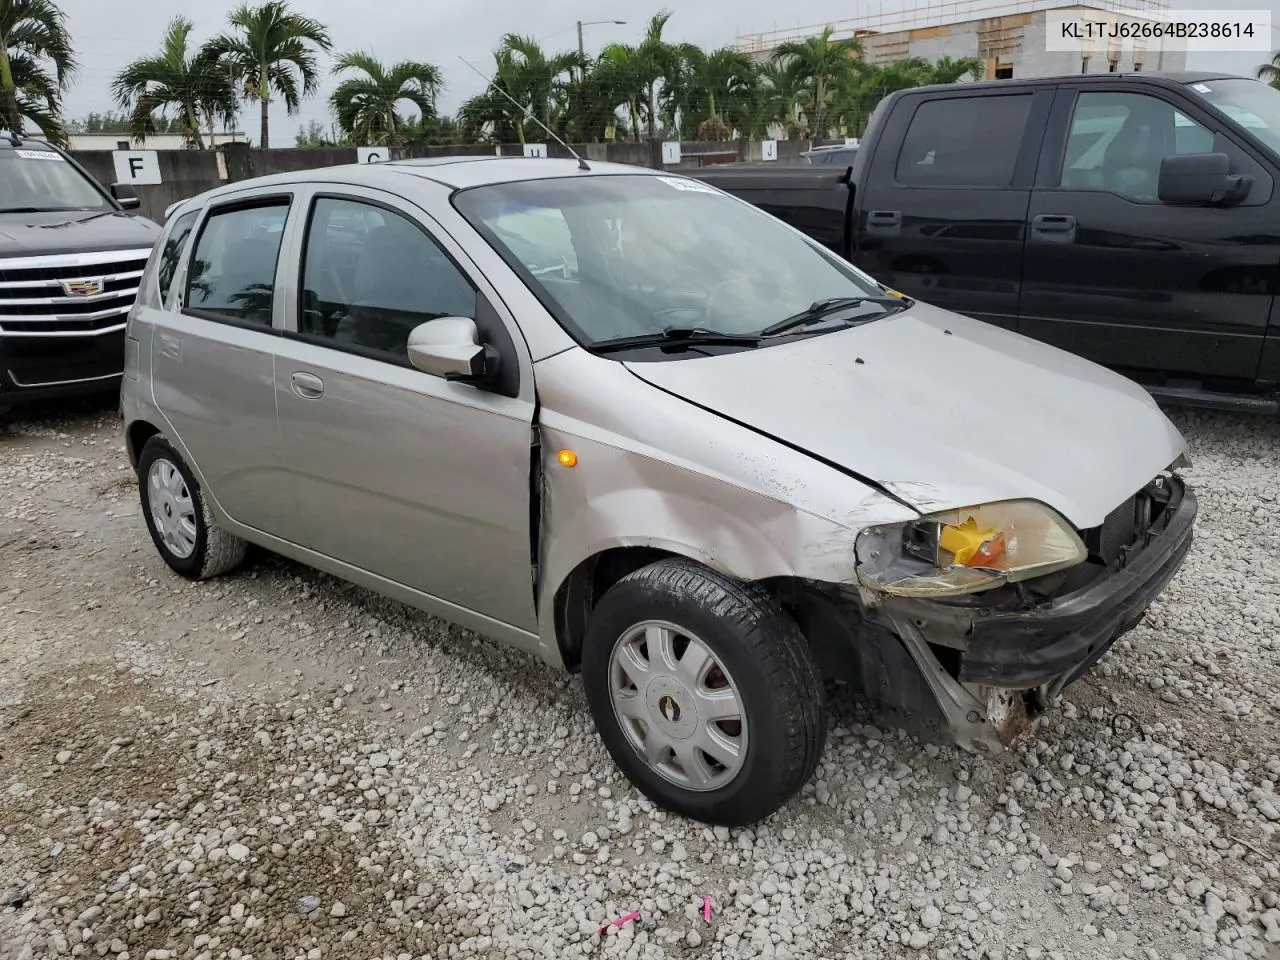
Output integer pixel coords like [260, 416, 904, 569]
[275, 188, 536, 631]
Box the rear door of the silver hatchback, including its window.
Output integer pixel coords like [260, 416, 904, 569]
[142, 193, 297, 536]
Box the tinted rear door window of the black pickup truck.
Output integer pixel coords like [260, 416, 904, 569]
[897, 93, 1032, 187]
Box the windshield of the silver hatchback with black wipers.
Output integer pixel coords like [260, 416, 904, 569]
[454, 174, 886, 346]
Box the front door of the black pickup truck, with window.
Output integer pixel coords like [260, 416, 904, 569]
[1018, 81, 1280, 389]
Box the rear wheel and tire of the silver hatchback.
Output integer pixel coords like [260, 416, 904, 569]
[138, 436, 248, 580]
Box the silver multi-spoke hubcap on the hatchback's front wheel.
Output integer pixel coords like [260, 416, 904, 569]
[609, 621, 748, 791]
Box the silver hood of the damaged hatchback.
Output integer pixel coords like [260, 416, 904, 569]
[626, 303, 1185, 530]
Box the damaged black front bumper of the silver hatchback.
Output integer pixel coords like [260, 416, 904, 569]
[806, 479, 1198, 754]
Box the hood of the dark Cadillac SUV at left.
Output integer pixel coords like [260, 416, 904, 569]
[0, 210, 160, 257]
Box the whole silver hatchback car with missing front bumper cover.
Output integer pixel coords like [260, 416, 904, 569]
[122, 159, 1196, 824]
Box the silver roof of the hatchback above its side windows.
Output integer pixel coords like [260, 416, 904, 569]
[169, 156, 678, 214]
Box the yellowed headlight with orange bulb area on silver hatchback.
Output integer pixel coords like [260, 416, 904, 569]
[855, 500, 1088, 596]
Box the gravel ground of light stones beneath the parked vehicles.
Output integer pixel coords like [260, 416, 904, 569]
[0, 407, 1280, 960]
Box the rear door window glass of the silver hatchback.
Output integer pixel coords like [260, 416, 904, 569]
[187, 201, 289, 326]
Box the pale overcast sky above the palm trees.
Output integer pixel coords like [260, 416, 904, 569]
[52, 0, 1280, 146]
